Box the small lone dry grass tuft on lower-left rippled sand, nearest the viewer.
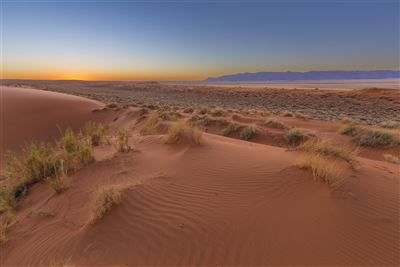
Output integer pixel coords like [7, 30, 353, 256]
[89, 187, 122, 224]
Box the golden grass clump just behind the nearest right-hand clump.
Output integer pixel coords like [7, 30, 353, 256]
[297, 139, 358, 166]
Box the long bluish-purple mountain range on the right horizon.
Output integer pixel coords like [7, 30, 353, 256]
[205, 70, 400, 82]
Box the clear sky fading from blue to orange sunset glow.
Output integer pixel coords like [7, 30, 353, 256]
[1, 0, 399, 80]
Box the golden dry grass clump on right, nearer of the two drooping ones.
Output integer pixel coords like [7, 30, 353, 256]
[295, 154, 340, 186]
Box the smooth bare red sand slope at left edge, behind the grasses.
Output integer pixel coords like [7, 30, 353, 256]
[0, 87, 117, 163]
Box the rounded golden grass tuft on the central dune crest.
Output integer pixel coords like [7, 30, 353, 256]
[165, 122, 202, 145]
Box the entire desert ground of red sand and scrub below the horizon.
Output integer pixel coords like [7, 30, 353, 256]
[0, 82, 400, 266]
